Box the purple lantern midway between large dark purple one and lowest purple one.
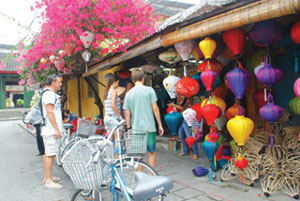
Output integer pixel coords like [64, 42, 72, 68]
[256, 56, 279, 87]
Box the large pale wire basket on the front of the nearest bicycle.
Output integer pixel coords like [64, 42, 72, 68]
[62, 139, 113, 189]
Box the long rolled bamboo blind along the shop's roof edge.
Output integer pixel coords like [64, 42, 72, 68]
[83, 0, 300, 77]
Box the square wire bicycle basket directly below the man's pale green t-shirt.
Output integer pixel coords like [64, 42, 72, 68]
[125, 129, 148, 155]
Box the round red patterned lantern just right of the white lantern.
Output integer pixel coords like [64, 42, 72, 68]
[176, 77, 200, 98]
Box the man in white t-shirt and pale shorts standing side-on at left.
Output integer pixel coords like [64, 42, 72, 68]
[41, 75, 63, 189]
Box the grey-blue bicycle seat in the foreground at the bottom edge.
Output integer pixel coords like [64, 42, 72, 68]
[133, 172, 173, 201]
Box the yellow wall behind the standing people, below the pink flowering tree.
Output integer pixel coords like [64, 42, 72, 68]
[67, 66, 122, 119]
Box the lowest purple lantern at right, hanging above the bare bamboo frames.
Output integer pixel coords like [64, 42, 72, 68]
[259, 94, 282, 124]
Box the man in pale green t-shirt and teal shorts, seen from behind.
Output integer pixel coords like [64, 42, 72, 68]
[123, 69, 164, 168]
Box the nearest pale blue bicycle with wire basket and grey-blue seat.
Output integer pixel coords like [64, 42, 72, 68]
[63, 120, 173, 201]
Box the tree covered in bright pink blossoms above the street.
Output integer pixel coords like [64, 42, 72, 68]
[15, 0, 157, 86]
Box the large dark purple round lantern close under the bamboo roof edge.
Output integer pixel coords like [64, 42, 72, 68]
[249, 20, 283, 47]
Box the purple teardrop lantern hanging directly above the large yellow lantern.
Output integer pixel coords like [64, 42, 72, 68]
[226, 65, 251, 99]
